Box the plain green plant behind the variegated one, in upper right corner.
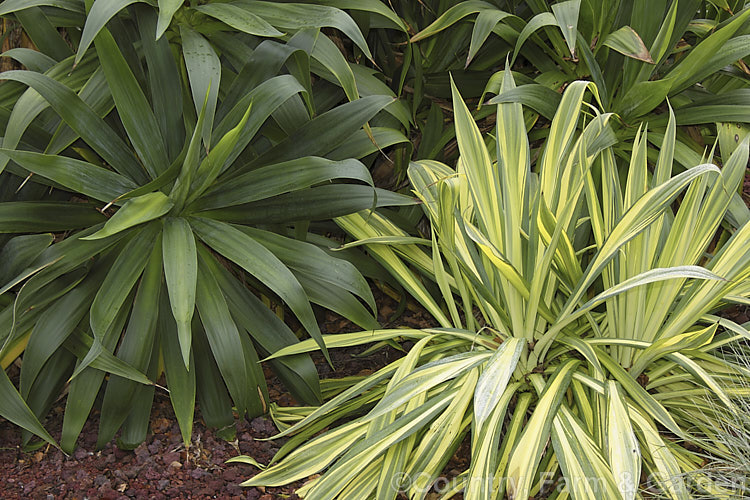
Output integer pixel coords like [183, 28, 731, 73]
[412, 0, 750, 226]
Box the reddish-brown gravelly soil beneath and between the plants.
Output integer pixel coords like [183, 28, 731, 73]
[0, 293, 446, 500]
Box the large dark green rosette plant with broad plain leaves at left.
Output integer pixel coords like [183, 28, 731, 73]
[0, 1, 413, 452]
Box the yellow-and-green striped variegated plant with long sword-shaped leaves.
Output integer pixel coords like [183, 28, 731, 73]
[239, 72, 750, 500]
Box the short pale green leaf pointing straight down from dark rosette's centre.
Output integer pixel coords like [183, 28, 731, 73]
[162, 217, 198, 368]
